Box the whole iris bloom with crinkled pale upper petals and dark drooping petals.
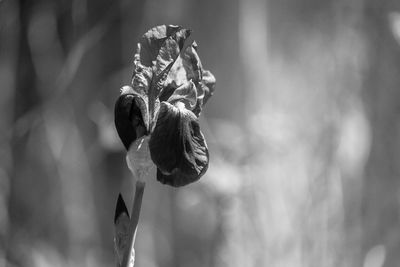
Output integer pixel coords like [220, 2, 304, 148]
[115, 25, 215, 186]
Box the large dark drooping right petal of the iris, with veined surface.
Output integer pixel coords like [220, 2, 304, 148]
[149, 102, 209, 186]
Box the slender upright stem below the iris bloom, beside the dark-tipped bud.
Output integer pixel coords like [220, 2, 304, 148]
[121, 180, 146, 267]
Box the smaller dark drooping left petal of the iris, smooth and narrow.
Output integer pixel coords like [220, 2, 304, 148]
[114, 87, 149, 150]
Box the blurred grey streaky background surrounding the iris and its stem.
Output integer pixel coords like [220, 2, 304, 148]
[0, 0, 400, 267]
